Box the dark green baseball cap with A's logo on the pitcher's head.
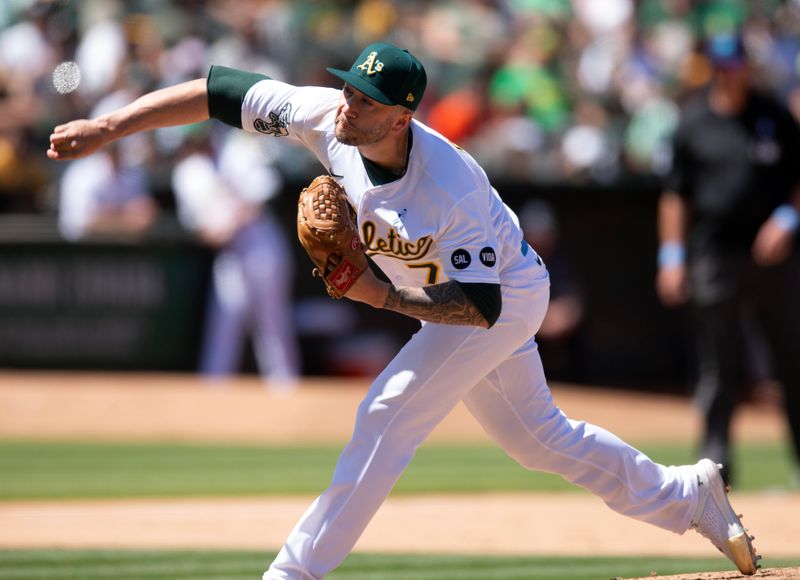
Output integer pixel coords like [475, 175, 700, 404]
[328, 42, 428, 111]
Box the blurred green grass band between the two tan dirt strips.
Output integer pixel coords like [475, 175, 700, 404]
[0, 441, 790, 500]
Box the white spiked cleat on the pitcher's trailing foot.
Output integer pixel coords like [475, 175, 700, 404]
[691, 459, 761, 576]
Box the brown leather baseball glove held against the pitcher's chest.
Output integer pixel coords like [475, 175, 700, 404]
[297, 175, 368, 298]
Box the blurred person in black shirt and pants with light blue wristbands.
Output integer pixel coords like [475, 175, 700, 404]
[656, 31, 800, 480]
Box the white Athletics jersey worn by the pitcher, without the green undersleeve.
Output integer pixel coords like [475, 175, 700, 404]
[212, 69, 528, 287]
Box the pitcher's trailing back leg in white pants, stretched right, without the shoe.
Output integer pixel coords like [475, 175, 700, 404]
[464, 341, 697, 533]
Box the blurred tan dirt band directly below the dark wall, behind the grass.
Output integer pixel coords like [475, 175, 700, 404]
[0, 373, 784, 444]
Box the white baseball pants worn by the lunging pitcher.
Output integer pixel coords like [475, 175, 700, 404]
[263, 267, 697, 580]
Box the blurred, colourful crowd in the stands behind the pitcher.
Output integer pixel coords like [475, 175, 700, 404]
[0, 0, 800, 212]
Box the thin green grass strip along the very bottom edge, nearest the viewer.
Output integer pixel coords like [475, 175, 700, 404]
[0, 550, 800, 580]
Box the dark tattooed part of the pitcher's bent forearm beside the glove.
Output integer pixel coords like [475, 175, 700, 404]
[383, 280, 489, 328]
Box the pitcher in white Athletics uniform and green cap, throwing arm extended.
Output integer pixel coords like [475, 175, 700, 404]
[48, 43, 757, 580]
